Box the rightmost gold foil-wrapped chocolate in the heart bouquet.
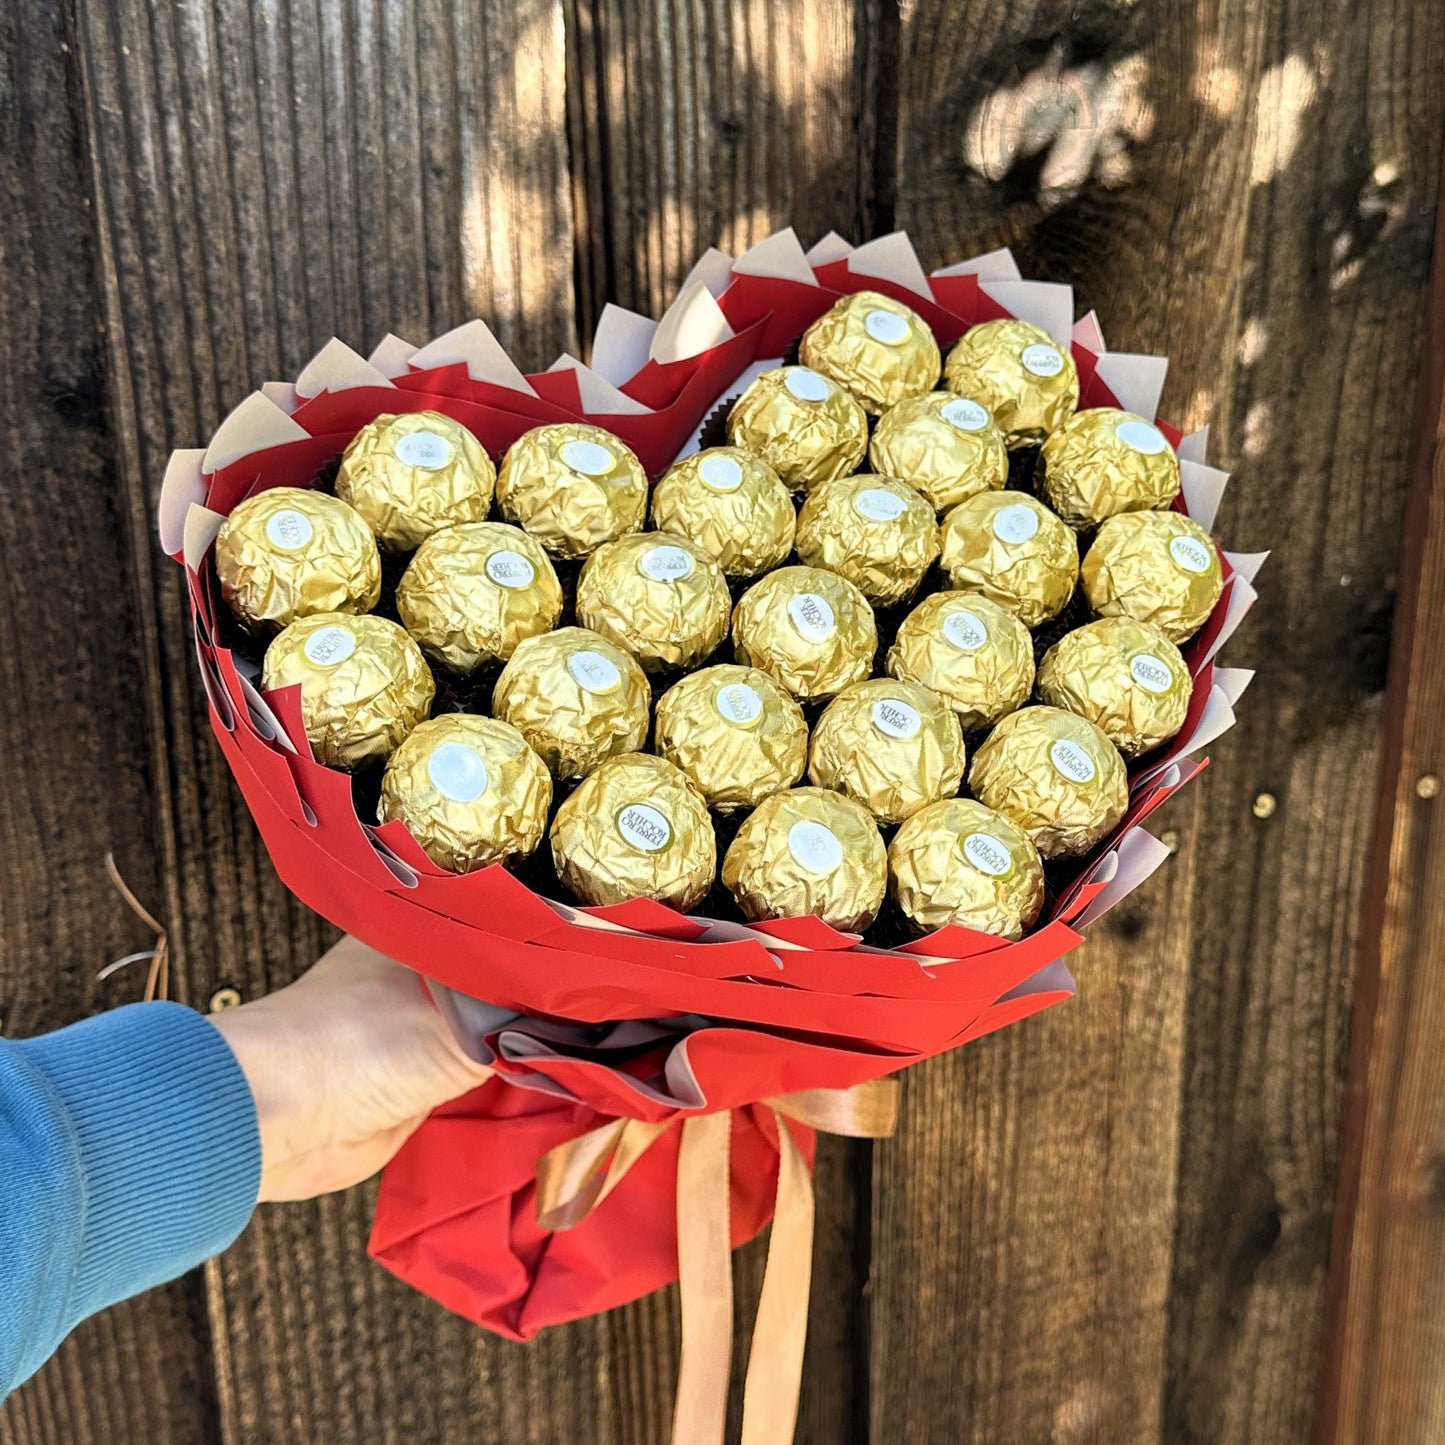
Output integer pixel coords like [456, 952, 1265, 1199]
[1079, 512, 1224, 643]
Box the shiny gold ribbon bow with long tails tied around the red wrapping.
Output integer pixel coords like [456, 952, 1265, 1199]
[538, 1079, 897, 1445]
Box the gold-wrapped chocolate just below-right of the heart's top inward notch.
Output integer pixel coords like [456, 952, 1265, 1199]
[652, 447, 798, 577]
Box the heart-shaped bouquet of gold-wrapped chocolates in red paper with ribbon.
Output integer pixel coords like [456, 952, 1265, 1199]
[160, 231, 1263, 1445]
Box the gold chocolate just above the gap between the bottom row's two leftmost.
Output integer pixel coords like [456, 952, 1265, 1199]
[491, 627, 652, 777]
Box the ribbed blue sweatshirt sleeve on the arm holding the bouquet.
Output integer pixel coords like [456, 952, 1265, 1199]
[0, 1003, 262, 1399]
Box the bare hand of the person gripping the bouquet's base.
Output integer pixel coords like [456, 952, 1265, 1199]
[211, 938, 491, 1201]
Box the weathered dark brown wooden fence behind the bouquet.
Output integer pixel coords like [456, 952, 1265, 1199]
[0, 0, 1445, 1445]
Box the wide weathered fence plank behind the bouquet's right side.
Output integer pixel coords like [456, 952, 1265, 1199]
[873, 0, 1445, 1442]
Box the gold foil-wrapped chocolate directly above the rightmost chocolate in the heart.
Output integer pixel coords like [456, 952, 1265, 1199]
[1038, 406, 1179, 527]
